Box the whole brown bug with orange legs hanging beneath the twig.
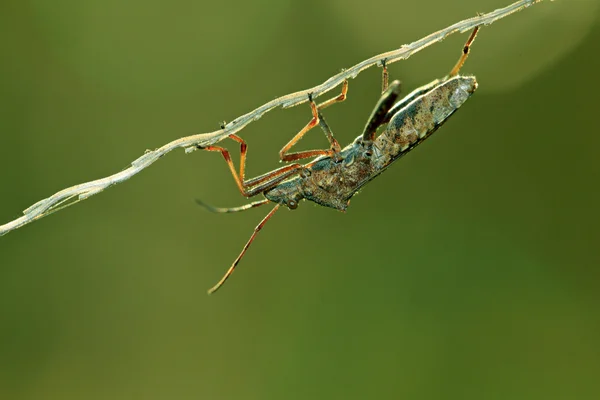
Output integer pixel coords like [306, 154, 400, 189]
[197, 27, 478, 294]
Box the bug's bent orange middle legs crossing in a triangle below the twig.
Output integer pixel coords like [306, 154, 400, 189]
[279, 81, 348, 161]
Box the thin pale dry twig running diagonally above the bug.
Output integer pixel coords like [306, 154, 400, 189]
[0, 0, 542, 236]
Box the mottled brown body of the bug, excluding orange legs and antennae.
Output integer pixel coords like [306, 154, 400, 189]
[264, 76, 477, 211]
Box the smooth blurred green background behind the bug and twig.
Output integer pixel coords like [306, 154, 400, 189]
[0, 0, 600, 399]
